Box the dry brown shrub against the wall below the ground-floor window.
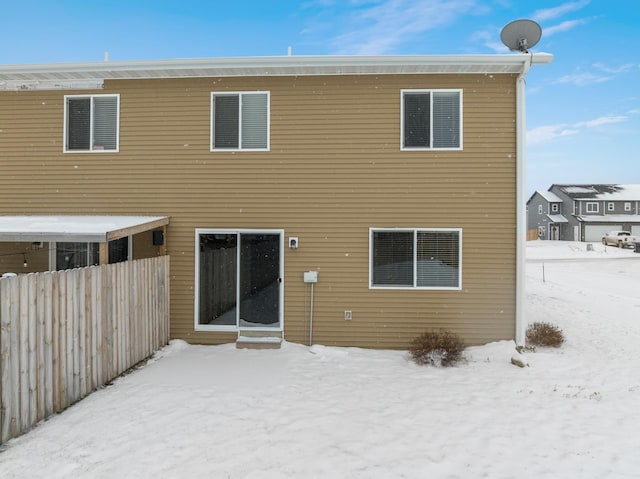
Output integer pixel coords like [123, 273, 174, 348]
[409, 330, 464, 367]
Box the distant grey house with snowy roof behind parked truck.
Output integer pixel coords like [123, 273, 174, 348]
[527, 184, 640, 242]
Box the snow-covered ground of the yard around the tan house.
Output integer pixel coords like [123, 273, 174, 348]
[0, 241, 640, 479]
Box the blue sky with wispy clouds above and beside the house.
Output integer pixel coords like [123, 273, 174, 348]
[0, 0, 640, 196]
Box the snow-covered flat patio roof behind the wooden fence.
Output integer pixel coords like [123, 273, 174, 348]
[0, 215, 169, 243]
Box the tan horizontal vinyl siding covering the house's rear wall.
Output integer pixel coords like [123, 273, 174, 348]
[0, 75, 516, 348]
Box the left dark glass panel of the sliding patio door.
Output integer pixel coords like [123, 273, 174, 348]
[198, 234, 238, 326]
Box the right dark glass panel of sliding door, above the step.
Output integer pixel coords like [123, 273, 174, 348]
[239, 234, 280, 328]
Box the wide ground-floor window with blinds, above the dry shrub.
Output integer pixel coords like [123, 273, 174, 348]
[369, 228, 462, 289]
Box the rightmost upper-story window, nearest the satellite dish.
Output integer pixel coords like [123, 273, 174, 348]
[400, 90, 462, 150]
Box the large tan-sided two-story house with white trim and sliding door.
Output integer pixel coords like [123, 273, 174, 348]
[0, 54, 552, 348]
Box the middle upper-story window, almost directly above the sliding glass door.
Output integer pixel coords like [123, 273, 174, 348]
[211, 92, 269, 151]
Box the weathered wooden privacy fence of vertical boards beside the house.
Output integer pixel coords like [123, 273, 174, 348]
[0, 256, 169, 443]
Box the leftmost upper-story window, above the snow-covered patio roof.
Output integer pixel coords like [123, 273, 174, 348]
[64, 95, 120, 152]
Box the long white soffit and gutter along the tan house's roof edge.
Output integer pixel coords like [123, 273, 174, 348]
[0, 53, 553, 89]
